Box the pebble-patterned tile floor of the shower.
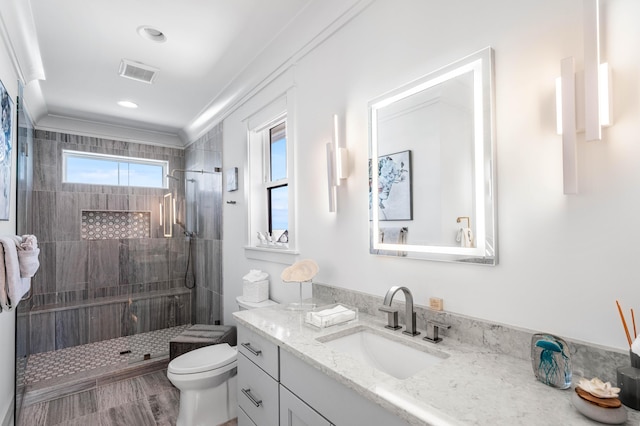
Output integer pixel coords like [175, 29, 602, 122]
[17, 325, 189, 386]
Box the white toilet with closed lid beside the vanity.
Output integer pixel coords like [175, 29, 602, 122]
[167, 296, 277, 426]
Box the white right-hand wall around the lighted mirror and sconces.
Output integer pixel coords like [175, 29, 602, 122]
[223, 0, 640, 348]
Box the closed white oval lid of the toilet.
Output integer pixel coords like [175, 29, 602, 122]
[168, 343, 238, 374]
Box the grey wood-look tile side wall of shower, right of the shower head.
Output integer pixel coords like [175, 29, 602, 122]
[185, 123, 224, 324]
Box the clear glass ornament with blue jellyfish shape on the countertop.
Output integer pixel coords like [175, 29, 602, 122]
[531, 333, 571, 389]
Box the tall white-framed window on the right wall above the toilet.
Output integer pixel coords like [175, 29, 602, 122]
[247, 94, 296, 252]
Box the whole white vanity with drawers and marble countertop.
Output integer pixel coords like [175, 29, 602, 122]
[233, 305, 640, 426]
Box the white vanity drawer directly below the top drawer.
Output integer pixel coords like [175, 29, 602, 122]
[238, 354, 279, 426]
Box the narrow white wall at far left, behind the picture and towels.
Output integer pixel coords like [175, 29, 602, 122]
[0, 34, 18, 423]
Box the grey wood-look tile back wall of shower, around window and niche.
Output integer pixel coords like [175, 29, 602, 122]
[19, 130, 192, 355]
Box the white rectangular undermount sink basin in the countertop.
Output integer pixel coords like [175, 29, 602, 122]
[317, 328, 448, 380]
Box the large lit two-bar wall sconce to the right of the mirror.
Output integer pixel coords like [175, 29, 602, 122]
[556, 0, 613, 194]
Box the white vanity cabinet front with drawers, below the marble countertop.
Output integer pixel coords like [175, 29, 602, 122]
[238, 326, 407, 426]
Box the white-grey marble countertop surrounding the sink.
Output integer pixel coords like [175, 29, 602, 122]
[233, 305, 640, 426]
